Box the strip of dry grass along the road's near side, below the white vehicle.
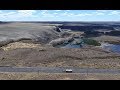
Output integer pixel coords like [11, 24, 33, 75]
[0, 72, 120, 80]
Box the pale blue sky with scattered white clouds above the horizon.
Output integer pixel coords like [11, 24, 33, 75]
[0, 10, 120, 21]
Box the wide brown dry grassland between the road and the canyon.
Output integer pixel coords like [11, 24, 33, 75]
[0, 42, 120, 69]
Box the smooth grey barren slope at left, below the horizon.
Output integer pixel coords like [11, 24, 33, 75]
[0, 23, 60, 46]
